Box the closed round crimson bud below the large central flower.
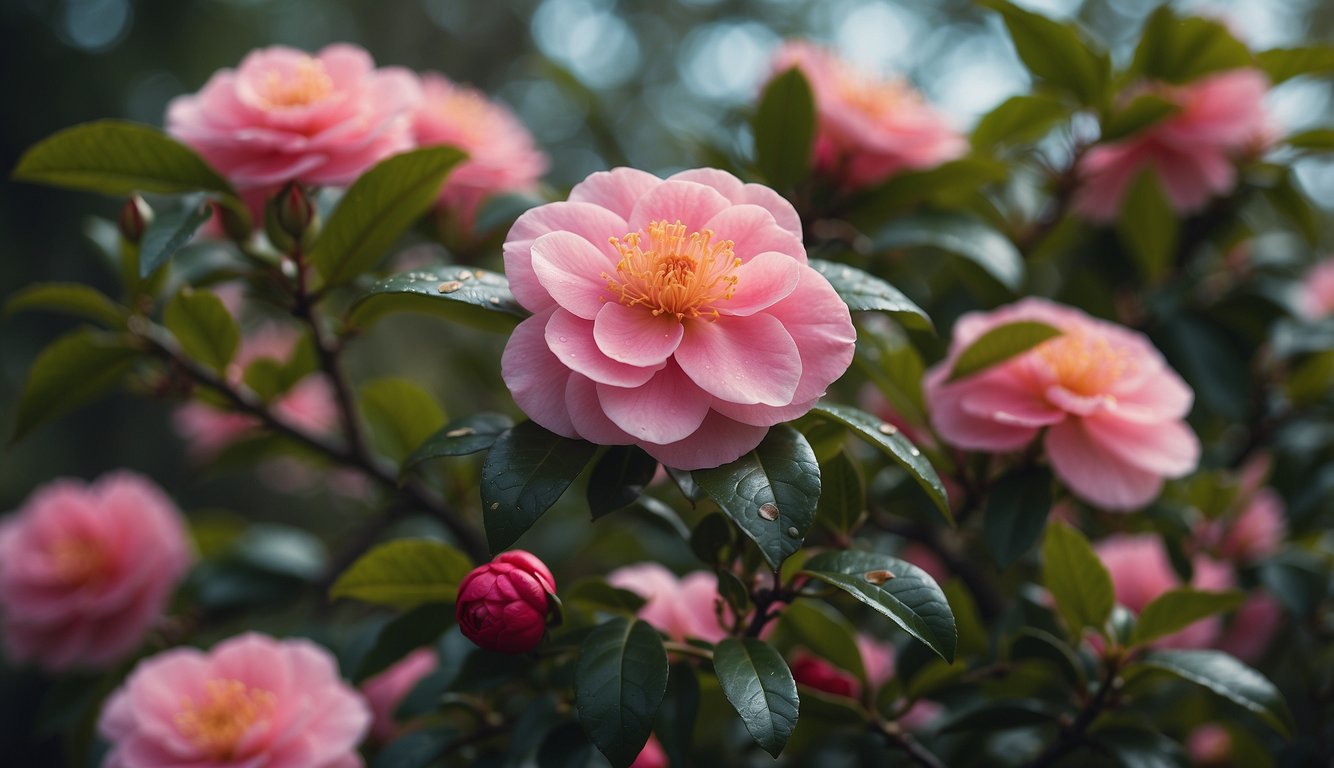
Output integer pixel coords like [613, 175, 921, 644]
[455, 549, 556, 653]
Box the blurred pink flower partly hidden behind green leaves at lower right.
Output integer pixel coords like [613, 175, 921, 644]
[1094, 533, 1233, 648]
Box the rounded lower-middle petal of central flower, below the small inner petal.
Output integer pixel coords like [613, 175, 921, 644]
[598, 360, 710, 443]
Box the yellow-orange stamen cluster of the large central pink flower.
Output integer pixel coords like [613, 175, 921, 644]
[602, 220, 742, 320]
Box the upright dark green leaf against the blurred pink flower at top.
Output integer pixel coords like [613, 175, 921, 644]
[751, 67, 815, 189]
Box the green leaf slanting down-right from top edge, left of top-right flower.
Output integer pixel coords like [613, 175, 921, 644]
[982, 0, 1111, 107]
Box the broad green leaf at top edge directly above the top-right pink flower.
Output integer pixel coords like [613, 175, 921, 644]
[1130, 4, 1254, 83]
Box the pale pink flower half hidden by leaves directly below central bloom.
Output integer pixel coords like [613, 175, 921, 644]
[607, 563, 730, 643]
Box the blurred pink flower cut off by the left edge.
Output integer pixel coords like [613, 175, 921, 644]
[0, 472, 193, 671]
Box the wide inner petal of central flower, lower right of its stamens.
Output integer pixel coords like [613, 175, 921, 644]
[672, 315, 802, 408]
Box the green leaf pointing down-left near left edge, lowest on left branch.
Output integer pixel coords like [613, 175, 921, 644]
[11, 329, 140, 441]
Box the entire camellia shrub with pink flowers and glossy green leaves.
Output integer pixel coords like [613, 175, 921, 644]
[0, 0, 1334, 768]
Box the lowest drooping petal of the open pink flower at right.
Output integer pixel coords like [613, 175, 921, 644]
[1046, 419, 1163, 509]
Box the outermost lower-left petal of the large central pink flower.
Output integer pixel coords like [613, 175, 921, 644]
[500, 309, 579, 437]
